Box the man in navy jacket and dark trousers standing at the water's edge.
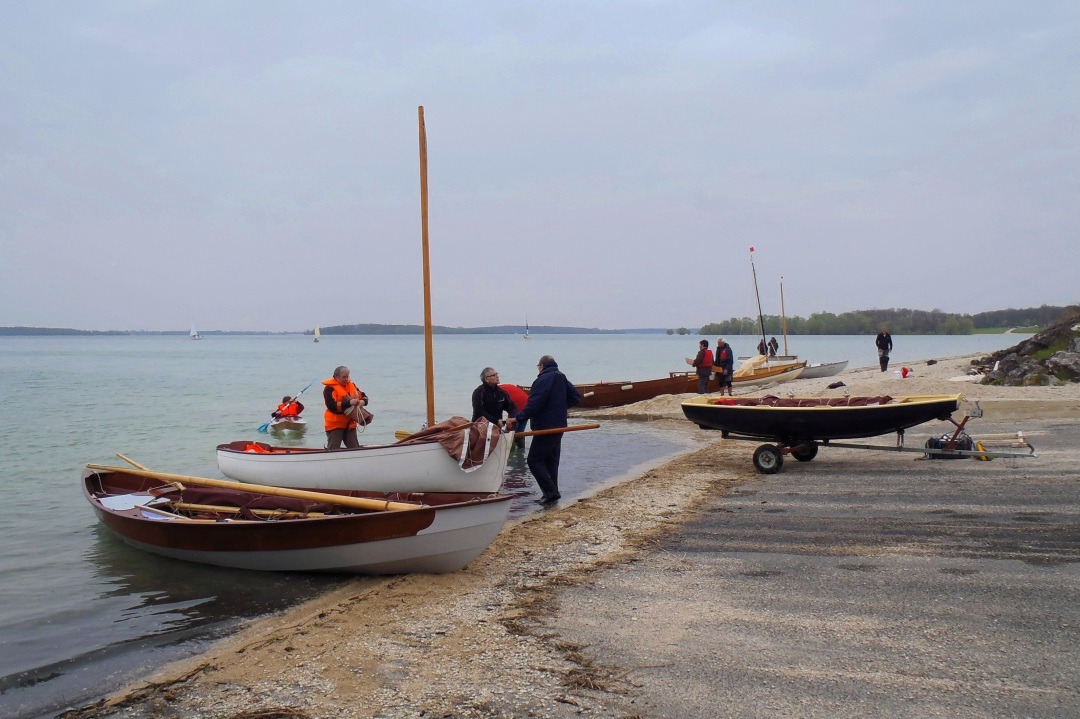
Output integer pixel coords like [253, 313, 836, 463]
[515, 354, 581, 504]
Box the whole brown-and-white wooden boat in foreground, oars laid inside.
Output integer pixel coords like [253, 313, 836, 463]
[82, 465, 511, 574]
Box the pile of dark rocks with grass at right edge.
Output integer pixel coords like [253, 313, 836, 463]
[971, 308, 1080, 386]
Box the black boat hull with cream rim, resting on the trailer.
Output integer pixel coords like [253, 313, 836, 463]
[681, 394, 960, 445]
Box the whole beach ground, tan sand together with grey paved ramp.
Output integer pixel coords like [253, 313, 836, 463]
[66, 356, 1080, 719]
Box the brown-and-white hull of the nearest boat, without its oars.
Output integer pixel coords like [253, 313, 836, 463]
[83, 472, 511, 574]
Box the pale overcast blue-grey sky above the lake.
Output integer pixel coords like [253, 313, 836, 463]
[0, 0, 1080, 331]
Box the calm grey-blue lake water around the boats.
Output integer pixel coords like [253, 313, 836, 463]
[0, 335, 1021, 719]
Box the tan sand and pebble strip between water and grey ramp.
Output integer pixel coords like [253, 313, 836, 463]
[71, 355, 1080, 719]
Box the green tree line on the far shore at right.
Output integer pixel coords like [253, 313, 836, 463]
[698, 304, 1070, 335]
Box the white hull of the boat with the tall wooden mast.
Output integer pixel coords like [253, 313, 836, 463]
[217, 432, 514, 492]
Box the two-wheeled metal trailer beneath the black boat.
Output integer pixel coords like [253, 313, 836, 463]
[723, 402, 1038, 474]
